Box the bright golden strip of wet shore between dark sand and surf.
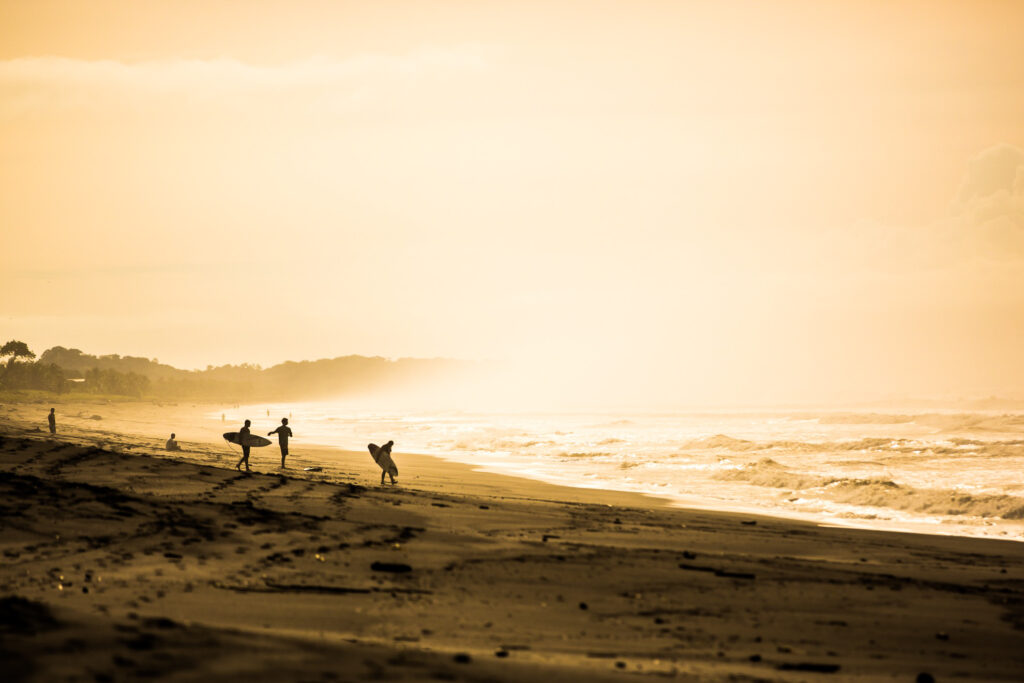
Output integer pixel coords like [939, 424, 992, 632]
[6, 399, 1024, 543]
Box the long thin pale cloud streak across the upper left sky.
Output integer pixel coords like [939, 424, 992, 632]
[0, 45, 488, 119]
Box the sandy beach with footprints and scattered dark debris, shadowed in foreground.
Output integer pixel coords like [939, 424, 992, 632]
[0, 403, 1024, 681]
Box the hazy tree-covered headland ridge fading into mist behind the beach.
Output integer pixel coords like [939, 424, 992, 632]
[0, 342, 474, 402]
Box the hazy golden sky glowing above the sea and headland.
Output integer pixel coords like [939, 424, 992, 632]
[0, 0, 1024, 405]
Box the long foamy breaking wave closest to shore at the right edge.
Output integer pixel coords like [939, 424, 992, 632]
[716, 458, 1024, 520]
